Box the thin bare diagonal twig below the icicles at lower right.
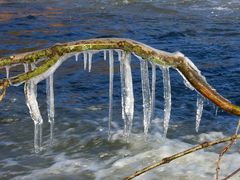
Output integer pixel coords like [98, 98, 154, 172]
[124, 135, 240, 180]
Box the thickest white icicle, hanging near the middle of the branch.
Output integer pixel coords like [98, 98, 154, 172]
[120, 52, 134, 140]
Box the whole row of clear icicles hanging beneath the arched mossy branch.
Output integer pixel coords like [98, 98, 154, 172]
[5, 50, 204, 152]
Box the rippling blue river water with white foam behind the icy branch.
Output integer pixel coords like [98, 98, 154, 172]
[0, 0, 240, 180]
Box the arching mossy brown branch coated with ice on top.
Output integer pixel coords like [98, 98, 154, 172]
[0, 38, 240, 116]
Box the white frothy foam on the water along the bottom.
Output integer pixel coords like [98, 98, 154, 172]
[14, 131, 240, 180]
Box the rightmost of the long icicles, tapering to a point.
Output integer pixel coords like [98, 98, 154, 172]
[161, 67, 172, 137]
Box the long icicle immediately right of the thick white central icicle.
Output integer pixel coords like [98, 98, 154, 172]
[140, 60, 151, 135]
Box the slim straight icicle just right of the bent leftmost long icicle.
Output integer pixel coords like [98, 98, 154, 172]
[46, 74, 55, 145]
